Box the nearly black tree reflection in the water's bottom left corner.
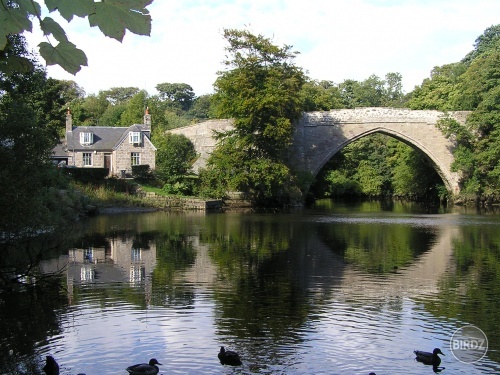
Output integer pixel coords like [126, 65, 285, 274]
[0, 279, 67, 374]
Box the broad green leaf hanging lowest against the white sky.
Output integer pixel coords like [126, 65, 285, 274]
[38, 42, 87, 75]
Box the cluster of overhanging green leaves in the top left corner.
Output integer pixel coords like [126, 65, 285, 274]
[0, 0, 153, 74]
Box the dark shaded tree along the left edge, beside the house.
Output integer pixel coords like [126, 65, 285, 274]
[0, 36, 71, 235]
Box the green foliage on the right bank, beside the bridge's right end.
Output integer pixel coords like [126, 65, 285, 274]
[428, 32, 500, 200]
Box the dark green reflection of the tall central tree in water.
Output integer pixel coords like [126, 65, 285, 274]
[203, 220, 342, 364]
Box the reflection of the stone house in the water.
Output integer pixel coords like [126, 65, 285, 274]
[68, 237, 156, 283]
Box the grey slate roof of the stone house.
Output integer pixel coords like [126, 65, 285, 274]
[66, 124, 150, 151]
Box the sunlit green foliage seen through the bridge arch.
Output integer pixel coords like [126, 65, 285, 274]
[311, 134, 444, 200]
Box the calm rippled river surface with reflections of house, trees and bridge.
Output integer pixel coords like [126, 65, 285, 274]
[0, 201, 500, 375]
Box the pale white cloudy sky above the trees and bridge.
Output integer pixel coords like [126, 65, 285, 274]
[26, 0, 500, 96]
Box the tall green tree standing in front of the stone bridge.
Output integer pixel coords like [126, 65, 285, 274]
[202, 29, 305, 205]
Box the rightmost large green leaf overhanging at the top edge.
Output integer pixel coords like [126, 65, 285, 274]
[89, 0, 151, 42]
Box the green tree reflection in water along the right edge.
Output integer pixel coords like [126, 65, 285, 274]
[421, 225, 500, 362]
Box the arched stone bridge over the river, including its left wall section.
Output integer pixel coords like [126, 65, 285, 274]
[171, 107, 468, 194]
